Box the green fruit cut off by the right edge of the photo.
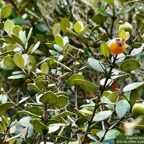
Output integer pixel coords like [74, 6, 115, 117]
[132, 103, 144, 117]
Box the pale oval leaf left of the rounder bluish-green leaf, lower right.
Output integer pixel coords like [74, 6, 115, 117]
[93, 110, 112, 122]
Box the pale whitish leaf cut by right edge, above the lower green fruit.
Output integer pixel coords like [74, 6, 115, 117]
[123, 82, 144, 92]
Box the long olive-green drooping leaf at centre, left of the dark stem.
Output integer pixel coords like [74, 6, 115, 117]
[75, 79, 97, 92]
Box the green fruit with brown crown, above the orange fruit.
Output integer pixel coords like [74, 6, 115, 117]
[119, 21, 133, 33]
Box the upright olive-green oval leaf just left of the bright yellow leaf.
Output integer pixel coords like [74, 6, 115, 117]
[60, 18, 70, 33]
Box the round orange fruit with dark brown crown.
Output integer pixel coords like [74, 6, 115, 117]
[108, 38, 126, 54]
